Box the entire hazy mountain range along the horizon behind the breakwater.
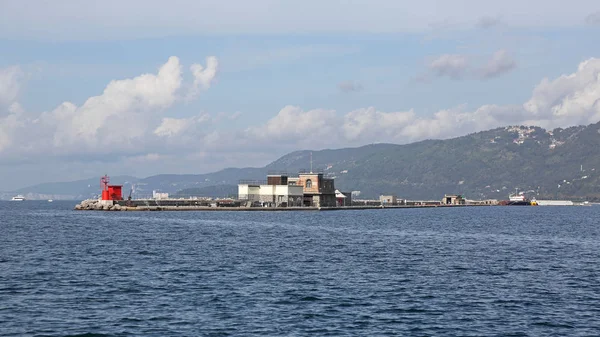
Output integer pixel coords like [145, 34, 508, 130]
[14, 123, 600, 199]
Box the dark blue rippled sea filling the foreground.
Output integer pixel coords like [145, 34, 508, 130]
[0, 201, 600, 336]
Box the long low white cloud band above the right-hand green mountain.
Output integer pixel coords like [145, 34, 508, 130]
[233, 59, 600, 150]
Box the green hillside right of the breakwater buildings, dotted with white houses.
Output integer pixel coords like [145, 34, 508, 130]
[326, 124, 600, 199]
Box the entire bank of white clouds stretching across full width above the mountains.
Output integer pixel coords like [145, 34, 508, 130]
[0, 54, 600, 181]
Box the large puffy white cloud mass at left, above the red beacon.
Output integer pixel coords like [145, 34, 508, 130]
[0, 56, 218, 155]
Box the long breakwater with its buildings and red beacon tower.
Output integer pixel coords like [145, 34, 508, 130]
[75, 172, 506, 210]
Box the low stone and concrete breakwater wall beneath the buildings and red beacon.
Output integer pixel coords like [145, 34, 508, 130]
[75, 200, 490, 212]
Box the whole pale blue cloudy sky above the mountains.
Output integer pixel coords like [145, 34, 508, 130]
[0, 0, 600, 191]
